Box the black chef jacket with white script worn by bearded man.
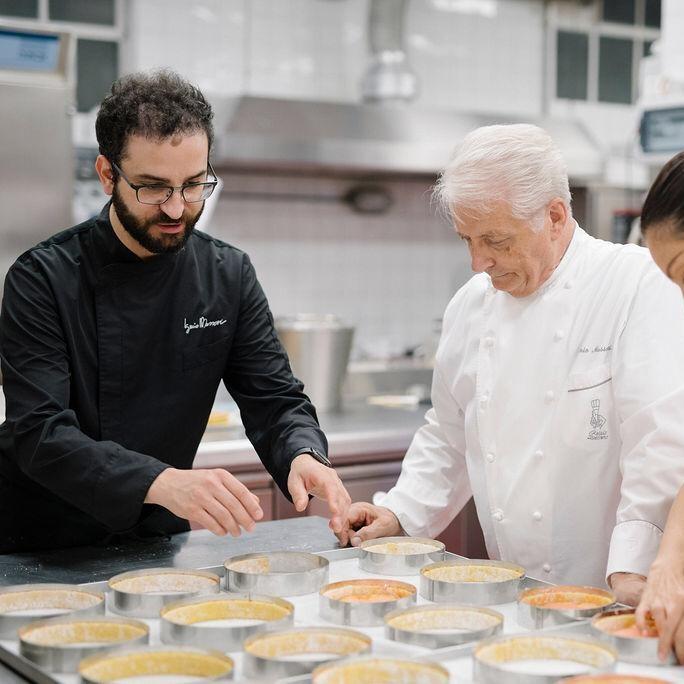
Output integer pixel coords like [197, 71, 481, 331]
[0, 205, 327, 553]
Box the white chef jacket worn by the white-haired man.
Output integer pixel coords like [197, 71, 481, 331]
[378, 226, 684, 585]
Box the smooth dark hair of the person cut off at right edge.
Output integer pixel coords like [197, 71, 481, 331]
[641, 152, 684, 235]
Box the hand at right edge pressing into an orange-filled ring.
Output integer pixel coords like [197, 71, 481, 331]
[636, 561, 684, 663]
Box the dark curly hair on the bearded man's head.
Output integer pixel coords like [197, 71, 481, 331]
[95, 69, 214, 166]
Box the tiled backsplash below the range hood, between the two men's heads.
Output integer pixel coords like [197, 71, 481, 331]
[207, 171, 471, 358]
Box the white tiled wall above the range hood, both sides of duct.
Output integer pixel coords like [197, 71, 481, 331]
[124, 0, 544, 115]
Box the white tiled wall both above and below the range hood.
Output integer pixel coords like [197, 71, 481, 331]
[116, 0, 543, 358]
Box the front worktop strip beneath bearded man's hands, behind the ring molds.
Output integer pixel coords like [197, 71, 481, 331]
[0, 516, 338, 586]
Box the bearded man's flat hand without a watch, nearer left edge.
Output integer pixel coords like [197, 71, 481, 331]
[145, 468, 264, 537]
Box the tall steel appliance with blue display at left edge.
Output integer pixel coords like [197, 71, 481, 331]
[0, 24, 74, 291]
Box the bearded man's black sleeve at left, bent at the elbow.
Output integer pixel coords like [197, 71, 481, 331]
[0, 256, 168, 532]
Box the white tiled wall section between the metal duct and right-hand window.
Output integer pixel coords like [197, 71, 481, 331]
[406, 0, 544, 116]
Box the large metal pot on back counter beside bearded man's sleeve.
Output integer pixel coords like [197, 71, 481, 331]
[276, 314, 354, 413]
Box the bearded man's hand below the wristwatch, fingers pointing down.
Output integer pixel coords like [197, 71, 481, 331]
[287, 453, 351, 534]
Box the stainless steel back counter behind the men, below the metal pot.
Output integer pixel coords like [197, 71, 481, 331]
[194, 403, 429, 468]
